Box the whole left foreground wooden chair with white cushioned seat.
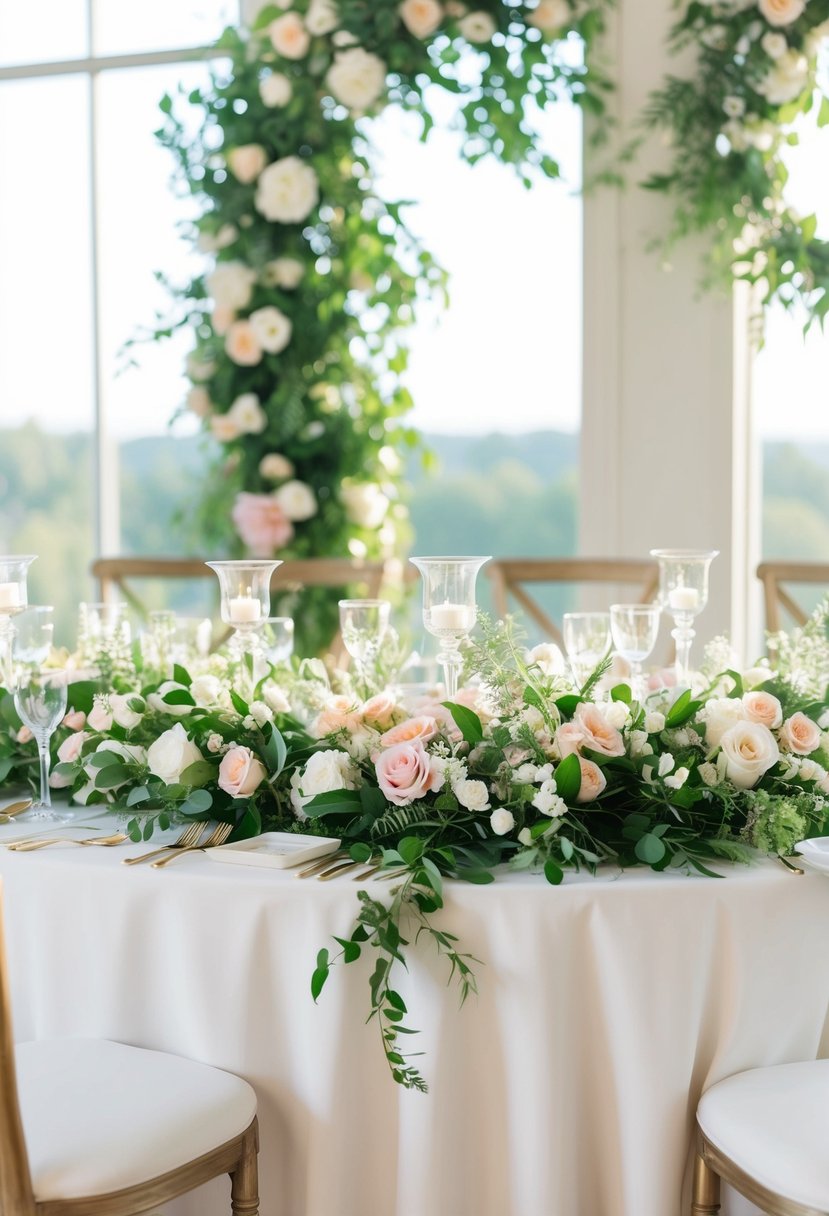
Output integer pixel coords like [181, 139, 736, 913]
[0, 890, 259, 1216]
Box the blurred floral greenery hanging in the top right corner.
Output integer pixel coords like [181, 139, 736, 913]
[645, 0, 829, 326]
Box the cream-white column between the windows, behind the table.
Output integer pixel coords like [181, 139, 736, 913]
[580, 0, 756, 653]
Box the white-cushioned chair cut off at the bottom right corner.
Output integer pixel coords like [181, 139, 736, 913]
[690, 1060, 829, 1216]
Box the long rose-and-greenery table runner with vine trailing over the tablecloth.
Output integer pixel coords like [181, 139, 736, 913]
[0, 602, 829, 1090]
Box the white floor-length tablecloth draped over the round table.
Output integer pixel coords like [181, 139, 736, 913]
[0, 831, 829, 1216]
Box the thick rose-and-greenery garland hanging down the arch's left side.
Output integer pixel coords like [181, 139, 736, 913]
[154, 0, 608, 651]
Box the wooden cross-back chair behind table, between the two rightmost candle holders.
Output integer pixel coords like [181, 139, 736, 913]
[485, 557, 659, 646]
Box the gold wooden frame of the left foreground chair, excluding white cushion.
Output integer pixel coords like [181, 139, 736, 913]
[0, 884, 259, 1216]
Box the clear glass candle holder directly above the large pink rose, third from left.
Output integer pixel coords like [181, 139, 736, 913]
[410, 557, 490, 700]
